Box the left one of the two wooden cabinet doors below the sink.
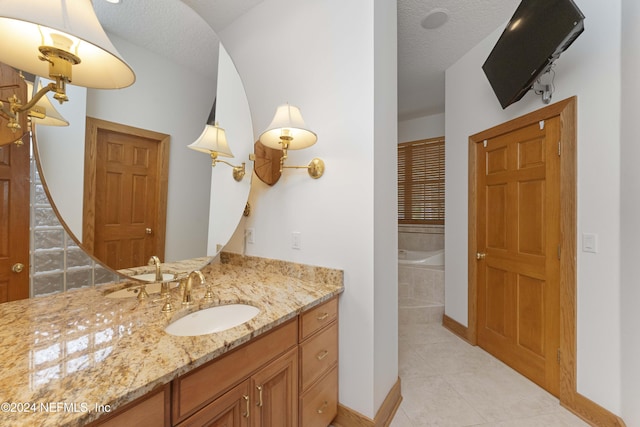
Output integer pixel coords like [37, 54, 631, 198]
[179, 380, 253, 427]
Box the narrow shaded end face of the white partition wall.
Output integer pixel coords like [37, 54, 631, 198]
[372, 0, 398, 409]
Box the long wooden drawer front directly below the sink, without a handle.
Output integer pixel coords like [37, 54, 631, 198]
[172, 320, 298, 423]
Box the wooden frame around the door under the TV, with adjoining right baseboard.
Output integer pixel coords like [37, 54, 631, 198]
[468, 97, 624, 426]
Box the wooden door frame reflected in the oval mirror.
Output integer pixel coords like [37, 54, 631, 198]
[82, 116, 171, 262]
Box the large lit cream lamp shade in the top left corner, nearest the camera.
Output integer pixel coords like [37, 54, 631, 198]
[0, 0, 135, 89]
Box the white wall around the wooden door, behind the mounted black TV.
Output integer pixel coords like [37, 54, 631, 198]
[445, 0, 621, 414]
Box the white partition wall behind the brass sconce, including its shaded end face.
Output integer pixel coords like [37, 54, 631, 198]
[220, 0, 398, 417]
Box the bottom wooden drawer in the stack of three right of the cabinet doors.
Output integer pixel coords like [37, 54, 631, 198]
[300, 366, 338, 427]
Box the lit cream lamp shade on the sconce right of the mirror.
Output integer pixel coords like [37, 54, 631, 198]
[259, 104, 318, 150]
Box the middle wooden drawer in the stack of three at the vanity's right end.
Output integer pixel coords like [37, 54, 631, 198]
[300, 322, 338, 390]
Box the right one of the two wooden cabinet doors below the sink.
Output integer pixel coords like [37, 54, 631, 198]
[251, 347, 298, 427]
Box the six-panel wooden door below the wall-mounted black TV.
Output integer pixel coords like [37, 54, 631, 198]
[476, 117, 561, 395]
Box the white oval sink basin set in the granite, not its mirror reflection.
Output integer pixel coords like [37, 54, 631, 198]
[164, 304, 260, 337]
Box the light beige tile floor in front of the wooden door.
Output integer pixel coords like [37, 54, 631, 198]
[391, 323, 587, 427]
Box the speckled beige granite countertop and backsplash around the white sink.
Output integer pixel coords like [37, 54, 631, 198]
[0, 255, 343, 426]
